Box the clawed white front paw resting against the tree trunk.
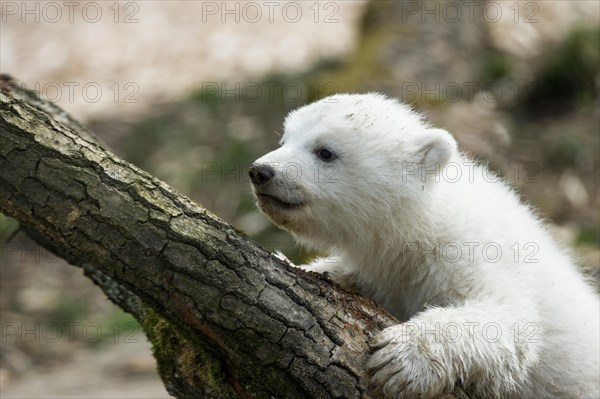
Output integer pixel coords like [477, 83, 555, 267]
[367, 324, 450, 398]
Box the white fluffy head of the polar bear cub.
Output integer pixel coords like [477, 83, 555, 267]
[249, 93, 457, 250]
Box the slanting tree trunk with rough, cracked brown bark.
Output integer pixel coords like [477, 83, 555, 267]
[0, 75, 463, 398]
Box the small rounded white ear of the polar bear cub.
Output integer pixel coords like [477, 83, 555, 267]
[413, 129, 457, 169]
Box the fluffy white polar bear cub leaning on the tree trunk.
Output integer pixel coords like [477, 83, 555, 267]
[249, 94, 600, 398]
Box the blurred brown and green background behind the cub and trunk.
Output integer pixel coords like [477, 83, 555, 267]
[0, 0, 600, 398]
